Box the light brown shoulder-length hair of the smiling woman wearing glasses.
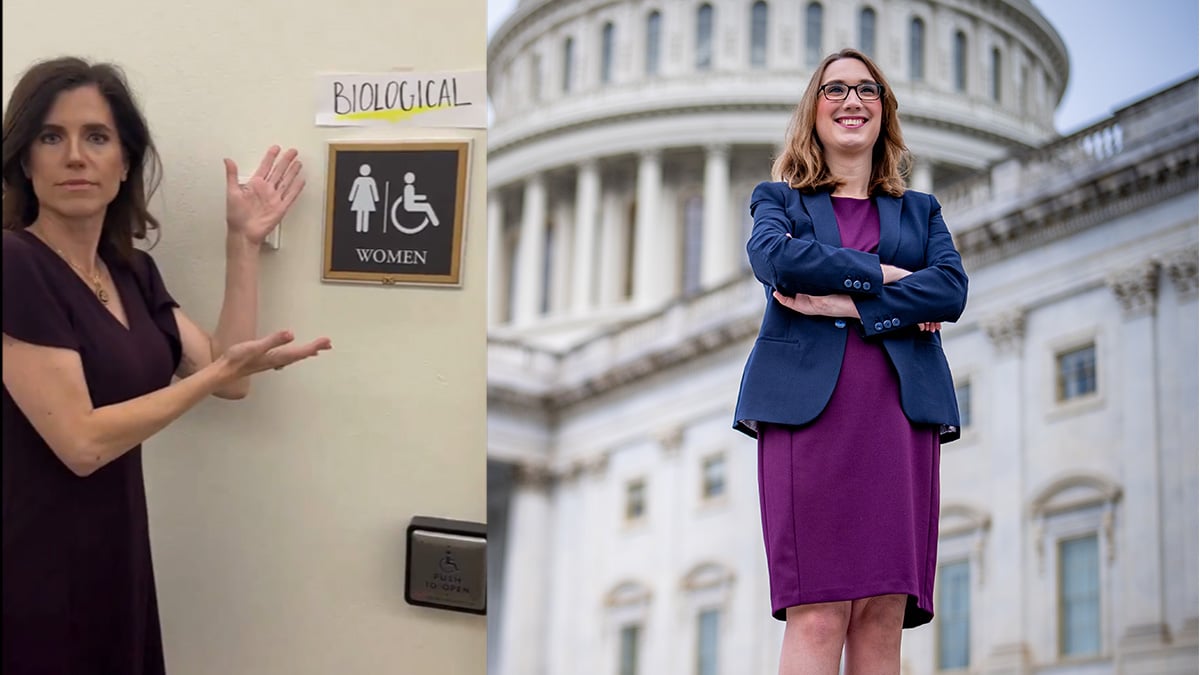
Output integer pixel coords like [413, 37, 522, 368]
[770, 49, 910, 197]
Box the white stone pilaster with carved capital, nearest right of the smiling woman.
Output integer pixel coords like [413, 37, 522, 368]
[972, 309, 1031, 675]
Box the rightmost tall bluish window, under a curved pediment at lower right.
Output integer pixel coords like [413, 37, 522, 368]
[1058, 534, 1100, 656]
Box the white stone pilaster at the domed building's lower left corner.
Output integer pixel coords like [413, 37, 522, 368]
[498, 464, 551, 675]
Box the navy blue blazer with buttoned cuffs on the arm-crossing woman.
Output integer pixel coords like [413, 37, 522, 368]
[733, 183, 967, 443]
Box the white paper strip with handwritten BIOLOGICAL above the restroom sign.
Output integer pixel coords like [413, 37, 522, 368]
[317, 70, 487, 129]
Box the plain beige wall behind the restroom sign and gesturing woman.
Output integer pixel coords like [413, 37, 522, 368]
[4, 0, 486, 675]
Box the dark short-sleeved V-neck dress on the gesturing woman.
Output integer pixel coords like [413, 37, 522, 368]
[0, 231, 180, 675]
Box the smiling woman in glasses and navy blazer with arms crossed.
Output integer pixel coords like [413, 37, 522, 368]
[734, 49, 967, 675]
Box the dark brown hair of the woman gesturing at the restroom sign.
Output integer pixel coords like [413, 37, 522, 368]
[0, 56, 162, 261]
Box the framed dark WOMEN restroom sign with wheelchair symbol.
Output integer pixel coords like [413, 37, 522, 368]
[322, 139, 470, 286]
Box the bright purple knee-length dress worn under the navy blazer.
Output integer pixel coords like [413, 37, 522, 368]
[758, 197, 941, 628]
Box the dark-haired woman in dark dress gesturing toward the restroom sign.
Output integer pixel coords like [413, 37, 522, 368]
[0, 58, 330, 675]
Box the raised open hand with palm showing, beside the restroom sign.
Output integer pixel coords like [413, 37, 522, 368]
[224, 145, 305, 244]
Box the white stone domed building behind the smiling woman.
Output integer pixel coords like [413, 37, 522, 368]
[487, 0, 1200, 675]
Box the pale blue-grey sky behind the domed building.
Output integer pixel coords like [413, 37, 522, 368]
[487, 0, 1200, 133]
